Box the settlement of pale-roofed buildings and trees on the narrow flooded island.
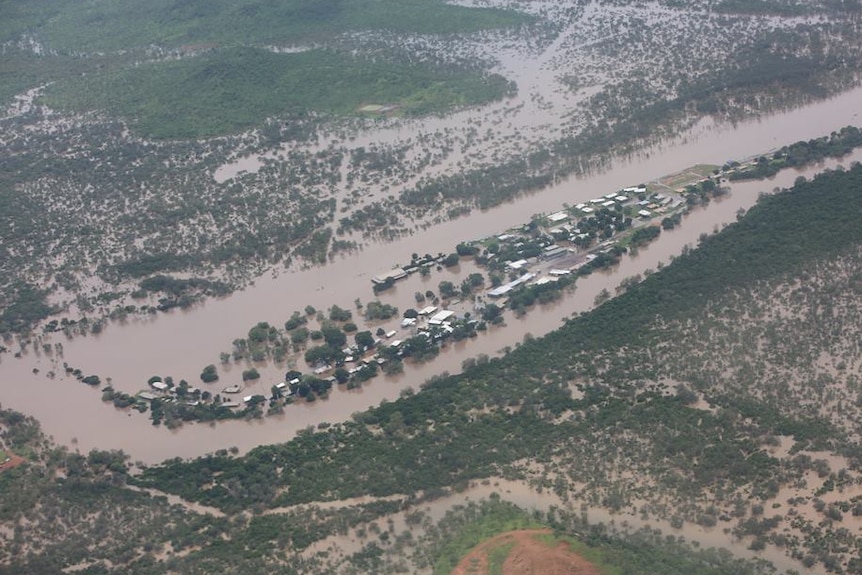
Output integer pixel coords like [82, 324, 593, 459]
[128, 169, 720, 422]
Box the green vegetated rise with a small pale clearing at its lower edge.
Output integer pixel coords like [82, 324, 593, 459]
[45, 48, 508, 138]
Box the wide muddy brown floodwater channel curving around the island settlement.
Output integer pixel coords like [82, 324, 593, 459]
[0, 89, 862, 463]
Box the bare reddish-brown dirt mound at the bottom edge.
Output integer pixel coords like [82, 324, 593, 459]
[452, 529, 601, 575]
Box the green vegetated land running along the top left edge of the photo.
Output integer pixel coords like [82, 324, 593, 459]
[0, 0, 527, 51]
